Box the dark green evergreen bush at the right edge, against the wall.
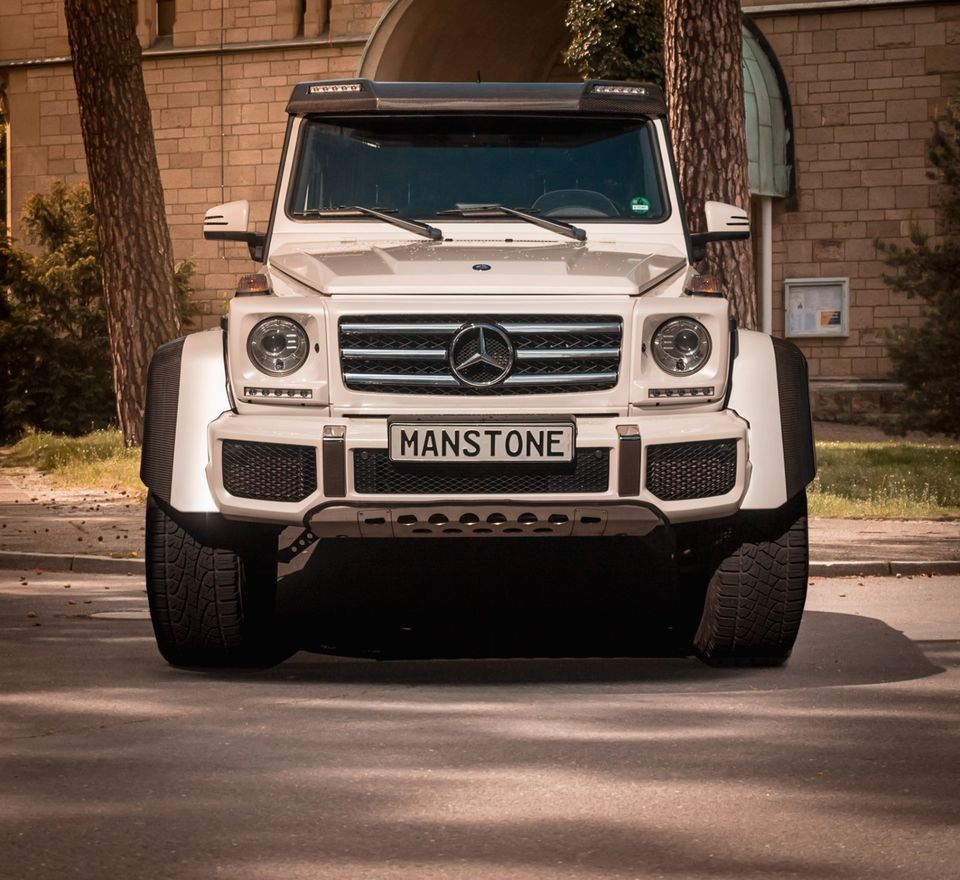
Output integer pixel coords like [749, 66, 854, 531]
[877, 104, 960, 437]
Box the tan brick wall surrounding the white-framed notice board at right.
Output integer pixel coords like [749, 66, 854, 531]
[744, 3, 960, 379]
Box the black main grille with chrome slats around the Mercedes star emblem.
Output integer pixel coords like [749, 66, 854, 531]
[340, 315, 623, 397]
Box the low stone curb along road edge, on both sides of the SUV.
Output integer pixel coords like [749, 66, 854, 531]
[0, 550, 960, 577]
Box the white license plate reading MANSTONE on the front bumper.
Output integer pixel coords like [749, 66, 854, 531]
[390, 422, 576, 463]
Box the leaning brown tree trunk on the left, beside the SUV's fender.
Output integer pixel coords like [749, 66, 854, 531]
[64, 0, 180, 444]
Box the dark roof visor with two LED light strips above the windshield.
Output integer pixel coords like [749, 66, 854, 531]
[287, 79, 667, 117]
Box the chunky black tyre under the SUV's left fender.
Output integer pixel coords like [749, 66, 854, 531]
[146, 495, 277, 667]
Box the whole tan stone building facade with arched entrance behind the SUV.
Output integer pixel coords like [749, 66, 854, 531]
[0, 0, 960, 392]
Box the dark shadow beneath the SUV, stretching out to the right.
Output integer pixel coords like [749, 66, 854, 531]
[255, 539, 943, 690]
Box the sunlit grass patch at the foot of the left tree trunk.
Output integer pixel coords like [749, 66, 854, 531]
[3, 430, 147, 498]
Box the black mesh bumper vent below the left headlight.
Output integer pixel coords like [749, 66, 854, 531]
[223, 440, 317, 501]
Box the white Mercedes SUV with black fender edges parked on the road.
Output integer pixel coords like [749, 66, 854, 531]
[142, 80, 815, 666]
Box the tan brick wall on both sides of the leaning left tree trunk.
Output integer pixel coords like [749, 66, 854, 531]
[0, 0, 388, 326]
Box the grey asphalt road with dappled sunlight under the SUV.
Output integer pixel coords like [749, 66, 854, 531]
[0, 563, 960, 880]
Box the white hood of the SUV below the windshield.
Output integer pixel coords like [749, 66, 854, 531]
[270, 242, 687, 296]
